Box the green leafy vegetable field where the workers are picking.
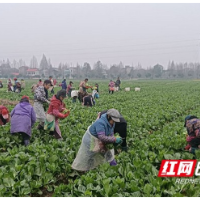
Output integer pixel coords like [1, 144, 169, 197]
[0, 80, 200, 198]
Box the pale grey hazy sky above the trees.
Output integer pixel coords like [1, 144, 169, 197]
[0, 2, 200, 68]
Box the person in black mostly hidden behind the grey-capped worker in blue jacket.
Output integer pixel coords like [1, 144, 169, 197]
[97, 110, 128, 152]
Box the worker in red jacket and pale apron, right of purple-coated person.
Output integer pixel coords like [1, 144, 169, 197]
[44, 90, 70, 139]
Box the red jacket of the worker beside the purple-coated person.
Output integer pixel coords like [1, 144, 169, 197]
[47, 95, 69, 119]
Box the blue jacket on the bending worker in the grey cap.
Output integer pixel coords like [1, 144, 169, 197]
[89, 114, 115, 137]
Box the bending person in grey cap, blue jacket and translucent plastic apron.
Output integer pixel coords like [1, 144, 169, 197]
[72, 109, 122, 172]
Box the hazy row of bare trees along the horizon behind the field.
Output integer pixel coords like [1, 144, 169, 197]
[0, 55, 200, 79]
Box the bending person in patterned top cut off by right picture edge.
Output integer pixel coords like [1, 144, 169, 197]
[184, 115, 200, 153]
